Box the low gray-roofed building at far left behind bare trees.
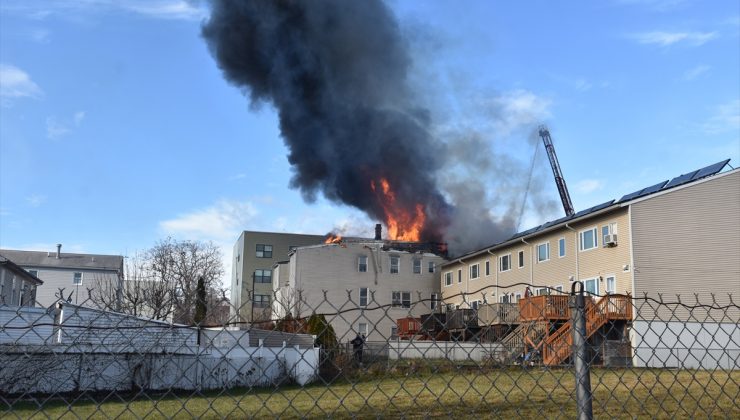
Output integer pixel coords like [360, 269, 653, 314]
[0, 244, 123, 307]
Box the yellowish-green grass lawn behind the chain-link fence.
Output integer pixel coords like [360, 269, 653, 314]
[7, 368, 740, 419]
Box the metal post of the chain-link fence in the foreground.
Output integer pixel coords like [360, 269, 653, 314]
[568, 281, 594, 420]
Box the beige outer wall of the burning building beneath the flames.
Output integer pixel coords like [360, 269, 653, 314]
[276, 242, 444, 342]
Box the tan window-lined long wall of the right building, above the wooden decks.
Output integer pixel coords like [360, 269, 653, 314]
[440, 208, 632, 307]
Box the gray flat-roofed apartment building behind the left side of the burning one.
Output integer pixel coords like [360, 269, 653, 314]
[231, 231, 326, 327]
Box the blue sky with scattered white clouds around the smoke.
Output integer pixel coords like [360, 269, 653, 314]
[0, 0, 740, 282]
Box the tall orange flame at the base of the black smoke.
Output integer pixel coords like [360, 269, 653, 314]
[370, 178, 426, 241]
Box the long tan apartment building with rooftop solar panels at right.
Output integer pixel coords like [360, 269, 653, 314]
[440, 160, 740, 368]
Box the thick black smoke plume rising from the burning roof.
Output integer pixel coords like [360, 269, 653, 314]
[202, 0, 454, 241]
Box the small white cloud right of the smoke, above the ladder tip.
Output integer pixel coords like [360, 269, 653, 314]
[488, 89, 552, 135]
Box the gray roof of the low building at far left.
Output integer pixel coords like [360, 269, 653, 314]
[0, 249, 123, 271]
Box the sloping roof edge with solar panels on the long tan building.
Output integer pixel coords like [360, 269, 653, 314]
[444, 159, 730, 265]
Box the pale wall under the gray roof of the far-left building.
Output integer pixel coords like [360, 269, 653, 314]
[23, 266, 123, 307]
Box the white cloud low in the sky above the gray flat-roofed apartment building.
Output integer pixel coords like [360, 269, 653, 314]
[159, 200, 258, 241]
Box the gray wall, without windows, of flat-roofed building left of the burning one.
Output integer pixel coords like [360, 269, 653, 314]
[231, 231, 325, 321]
